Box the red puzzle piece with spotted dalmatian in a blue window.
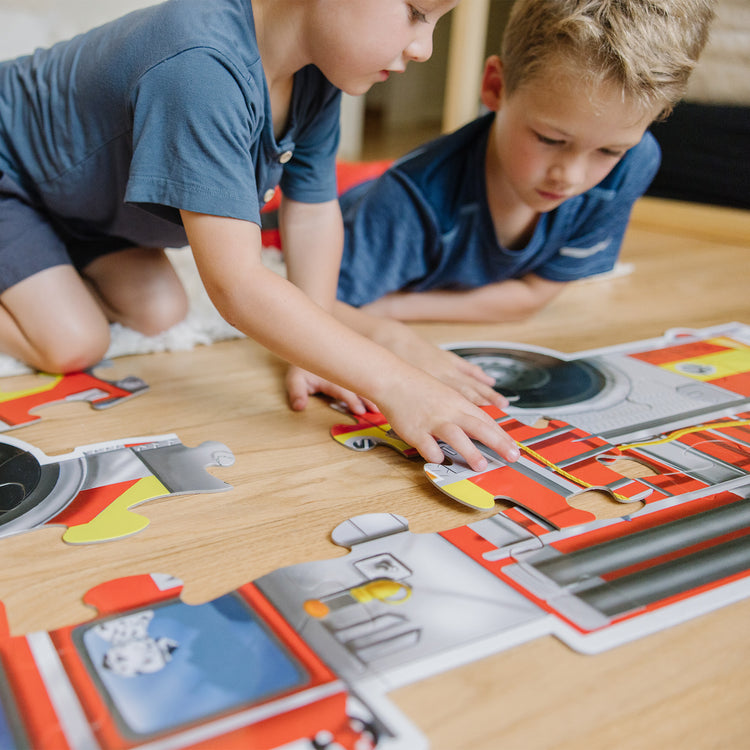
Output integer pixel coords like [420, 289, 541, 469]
[0, 575, 425, 750]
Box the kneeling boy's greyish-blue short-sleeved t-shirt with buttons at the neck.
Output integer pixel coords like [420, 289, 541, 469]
[0, 0, 340, 253]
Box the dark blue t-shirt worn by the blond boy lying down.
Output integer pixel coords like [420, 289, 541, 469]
[338, 113, 660, 306]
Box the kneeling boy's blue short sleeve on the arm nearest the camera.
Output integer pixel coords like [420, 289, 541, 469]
[125, 48, 262, 223]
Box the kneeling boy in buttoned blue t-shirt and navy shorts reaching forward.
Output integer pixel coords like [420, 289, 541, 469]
[0, 0, 518, 468]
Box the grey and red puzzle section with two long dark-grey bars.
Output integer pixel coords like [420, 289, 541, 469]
[256, 488, 750, 689]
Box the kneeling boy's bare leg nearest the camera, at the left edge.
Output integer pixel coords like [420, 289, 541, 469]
[0, 265, 109, 372]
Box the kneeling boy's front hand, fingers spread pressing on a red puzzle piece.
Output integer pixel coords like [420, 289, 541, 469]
[380, 376, 520, 471]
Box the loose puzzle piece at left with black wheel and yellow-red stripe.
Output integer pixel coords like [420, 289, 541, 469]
[0, 435, 234, 544]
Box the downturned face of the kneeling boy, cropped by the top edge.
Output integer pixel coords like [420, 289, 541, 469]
[308, 0, 458, 95]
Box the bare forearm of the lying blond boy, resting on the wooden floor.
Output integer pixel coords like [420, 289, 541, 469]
[361, 274, 565, 323]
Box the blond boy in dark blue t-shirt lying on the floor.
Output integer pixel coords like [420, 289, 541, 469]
[338, 0, 714, 322]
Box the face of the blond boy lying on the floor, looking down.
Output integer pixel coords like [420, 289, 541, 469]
[482, 58, 657, 213]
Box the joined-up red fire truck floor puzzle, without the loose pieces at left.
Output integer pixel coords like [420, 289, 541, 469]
[0, 324, 750, 750]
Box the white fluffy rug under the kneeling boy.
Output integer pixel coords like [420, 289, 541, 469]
[0, 248, 285, 377]
